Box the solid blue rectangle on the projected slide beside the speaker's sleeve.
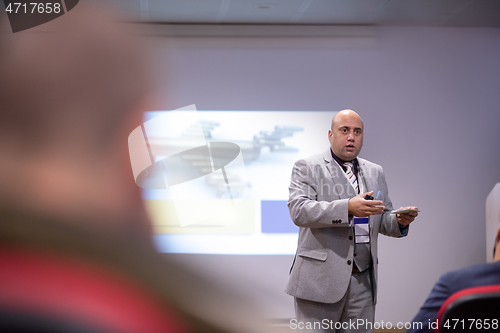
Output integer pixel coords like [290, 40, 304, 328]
[260, 200, 299, 234]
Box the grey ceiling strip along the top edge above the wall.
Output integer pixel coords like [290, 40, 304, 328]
[87, 0, 500, 27]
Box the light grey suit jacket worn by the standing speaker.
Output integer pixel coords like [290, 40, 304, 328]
[285, 149, 403, 303]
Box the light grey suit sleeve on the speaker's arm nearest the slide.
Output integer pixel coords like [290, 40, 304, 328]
[288, 160, 349, 228]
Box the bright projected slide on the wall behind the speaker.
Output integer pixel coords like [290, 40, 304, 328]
[139, 106, 334, 254]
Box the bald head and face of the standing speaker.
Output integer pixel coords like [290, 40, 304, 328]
[328, 111, 363, 161]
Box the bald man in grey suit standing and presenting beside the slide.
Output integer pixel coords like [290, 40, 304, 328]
[285, 110, 418, 332]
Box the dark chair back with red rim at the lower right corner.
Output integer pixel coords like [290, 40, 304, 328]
[436, 285, 500, 333]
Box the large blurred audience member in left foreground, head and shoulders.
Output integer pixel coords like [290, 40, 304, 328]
[0, 5, 259, 332]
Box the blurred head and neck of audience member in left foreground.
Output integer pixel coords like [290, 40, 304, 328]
[0, 4, 152, 233]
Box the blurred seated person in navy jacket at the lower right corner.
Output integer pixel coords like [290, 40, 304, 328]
[406, 220, 500, 333]
